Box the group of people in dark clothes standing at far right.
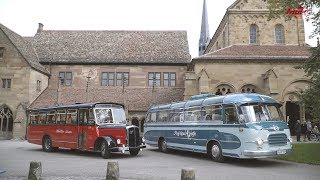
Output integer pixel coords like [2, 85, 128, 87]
[295, 120, 320, 142]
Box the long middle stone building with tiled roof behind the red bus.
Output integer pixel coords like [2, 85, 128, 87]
[30, 24, 191, 133]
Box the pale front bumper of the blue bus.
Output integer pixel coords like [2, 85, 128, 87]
[243, 149, 292, 158]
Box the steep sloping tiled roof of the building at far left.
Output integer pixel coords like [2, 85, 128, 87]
[0, 23, 49, 74]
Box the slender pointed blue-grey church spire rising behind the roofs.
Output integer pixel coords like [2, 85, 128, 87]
[199, 0, 210, 56]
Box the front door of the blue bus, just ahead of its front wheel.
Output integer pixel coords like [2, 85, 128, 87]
[220, 104, 243, 157]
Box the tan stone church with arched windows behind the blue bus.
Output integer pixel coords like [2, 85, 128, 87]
[185, 0, 310, 134]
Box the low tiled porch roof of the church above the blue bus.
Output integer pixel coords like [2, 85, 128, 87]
[193, 45, 311, 60]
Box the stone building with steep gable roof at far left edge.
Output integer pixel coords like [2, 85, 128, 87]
[0, 24, 50, 139]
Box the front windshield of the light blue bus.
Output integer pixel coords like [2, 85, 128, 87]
[239, 104, 282, 123]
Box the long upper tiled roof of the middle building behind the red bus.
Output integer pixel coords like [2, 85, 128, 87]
[32, 30, 191, 64]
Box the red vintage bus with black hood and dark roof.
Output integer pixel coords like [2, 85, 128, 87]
[27, 103, 146, 158]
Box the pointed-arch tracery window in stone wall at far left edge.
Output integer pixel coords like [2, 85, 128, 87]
[0, 105, 13, 139]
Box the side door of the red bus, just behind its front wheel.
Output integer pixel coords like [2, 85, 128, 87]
[78, 108, 96, 150]
